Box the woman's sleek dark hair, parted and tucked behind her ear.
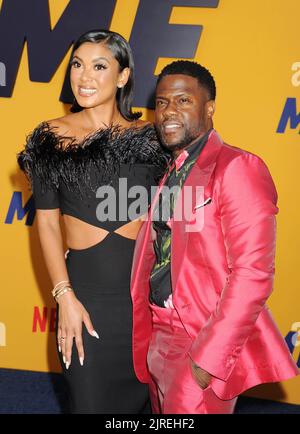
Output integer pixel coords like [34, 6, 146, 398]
[69, 30, 142, 121]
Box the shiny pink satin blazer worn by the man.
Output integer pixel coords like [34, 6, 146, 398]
[131, 131, 298, 399]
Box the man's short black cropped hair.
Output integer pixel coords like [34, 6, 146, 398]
[156, 60, 216, 100]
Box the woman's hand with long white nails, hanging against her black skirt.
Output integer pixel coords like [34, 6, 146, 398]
[57, 291, 99, 369]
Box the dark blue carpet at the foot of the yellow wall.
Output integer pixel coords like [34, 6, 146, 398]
[0, 369, 300, 414]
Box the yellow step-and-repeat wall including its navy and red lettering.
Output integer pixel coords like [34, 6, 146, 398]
[0, 0, 300, 404]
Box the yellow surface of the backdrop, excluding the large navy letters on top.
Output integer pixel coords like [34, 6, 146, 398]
[0, 0, 300, 404]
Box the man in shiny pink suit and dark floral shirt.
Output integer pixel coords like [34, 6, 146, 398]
[131, 61, 298, 414]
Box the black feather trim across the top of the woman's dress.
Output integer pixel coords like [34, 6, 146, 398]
[17, 122, 168, 195]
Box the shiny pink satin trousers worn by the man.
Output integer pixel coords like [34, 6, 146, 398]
[147, 305, 237, 414]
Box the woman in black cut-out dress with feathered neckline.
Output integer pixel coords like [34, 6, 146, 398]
[18, 30, 166, 413]
